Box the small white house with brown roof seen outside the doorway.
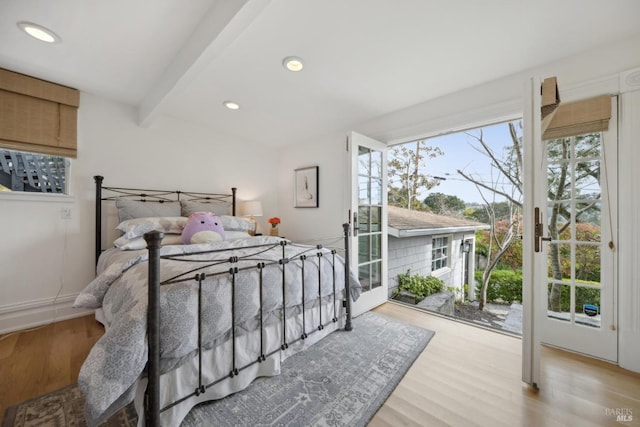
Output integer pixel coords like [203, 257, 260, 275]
[388, 206, 489, 299]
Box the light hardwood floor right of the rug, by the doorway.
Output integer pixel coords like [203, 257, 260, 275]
[369, 303, 640, 427]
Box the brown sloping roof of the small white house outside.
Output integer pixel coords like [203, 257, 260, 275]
[387, 206, 490, 237]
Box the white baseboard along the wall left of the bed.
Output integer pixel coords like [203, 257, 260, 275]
[0, 294, 93, 334]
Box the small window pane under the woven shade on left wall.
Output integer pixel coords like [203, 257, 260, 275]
[0, 148, 70, 194]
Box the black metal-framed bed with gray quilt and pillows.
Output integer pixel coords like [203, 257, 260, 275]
[75, 176, 360, 426]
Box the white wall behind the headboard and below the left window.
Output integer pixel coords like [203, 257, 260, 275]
[0, 93, 278, 333]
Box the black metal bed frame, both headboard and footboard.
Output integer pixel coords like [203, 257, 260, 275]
[94, 176, 353, 426]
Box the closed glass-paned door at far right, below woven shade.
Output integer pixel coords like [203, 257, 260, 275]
[534, 97, 618, 362]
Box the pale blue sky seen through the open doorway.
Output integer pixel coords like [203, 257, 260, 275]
[389, 119, 522, 203]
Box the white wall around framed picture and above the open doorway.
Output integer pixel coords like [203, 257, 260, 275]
[280, 36, 640, 372]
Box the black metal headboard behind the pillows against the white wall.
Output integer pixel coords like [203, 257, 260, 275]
[93, 175, 237, 264]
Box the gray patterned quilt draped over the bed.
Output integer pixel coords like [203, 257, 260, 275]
[74, 236, 360, 425]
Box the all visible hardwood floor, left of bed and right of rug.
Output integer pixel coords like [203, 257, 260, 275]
[0, 303, 640, 427]
